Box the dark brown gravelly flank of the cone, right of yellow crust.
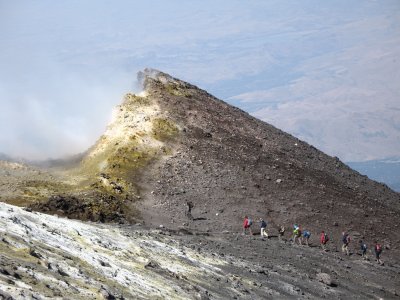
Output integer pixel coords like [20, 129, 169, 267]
[134, 71, 400, 258]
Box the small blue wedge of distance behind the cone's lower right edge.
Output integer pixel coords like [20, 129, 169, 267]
[347, 158, 400, 192]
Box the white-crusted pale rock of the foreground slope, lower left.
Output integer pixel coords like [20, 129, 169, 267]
[0, 203, 238, 299]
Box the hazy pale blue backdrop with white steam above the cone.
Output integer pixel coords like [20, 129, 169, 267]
[0, 0, 400, 161]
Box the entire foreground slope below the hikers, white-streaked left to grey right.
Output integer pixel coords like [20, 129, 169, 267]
[0, 203, 400, 299]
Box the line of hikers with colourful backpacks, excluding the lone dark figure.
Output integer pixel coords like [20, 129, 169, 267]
[243, 216, 383, 264]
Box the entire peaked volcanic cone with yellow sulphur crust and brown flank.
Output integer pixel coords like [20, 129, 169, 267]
[2, 69, 400, 253]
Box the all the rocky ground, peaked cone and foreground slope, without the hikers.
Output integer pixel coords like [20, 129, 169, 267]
[0, 70, 400, 299]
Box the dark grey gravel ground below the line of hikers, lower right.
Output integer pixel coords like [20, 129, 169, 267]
[120, 221, 400, 299]
